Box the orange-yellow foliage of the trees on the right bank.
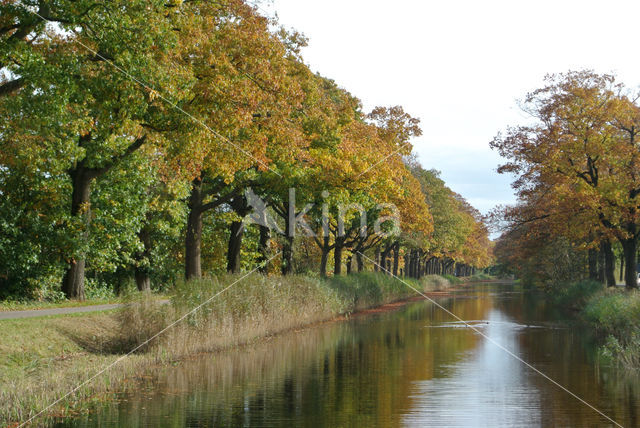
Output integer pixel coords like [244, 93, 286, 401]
[492, 71, 640, 274]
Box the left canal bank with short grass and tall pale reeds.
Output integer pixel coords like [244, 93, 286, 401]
[0, 273, 460, 426]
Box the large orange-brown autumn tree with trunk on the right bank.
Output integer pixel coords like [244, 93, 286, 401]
[492, 71, 640, 288]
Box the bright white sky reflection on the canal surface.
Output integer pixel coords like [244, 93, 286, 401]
[404, 309, 540, 427]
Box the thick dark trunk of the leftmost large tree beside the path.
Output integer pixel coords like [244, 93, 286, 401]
[62, 167, 94, 300]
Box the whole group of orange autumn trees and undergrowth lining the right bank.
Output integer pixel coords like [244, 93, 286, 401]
[492, 71, 640, 288]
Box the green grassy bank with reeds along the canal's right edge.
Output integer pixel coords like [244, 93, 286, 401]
[551, 281, 640, 368]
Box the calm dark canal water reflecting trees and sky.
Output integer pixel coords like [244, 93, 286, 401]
[54, 285, 640, 427]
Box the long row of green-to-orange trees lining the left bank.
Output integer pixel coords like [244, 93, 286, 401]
[0, 0, 490, 299]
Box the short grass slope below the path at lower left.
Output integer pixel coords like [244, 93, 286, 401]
[0, 313, 146, 426]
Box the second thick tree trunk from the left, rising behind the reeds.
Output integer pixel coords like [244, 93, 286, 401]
[185, 178, 203, 281]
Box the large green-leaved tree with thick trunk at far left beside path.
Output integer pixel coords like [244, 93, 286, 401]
[0, 1, 196, 299]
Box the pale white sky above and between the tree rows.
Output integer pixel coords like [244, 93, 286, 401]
[261, 0, 640, 213]
